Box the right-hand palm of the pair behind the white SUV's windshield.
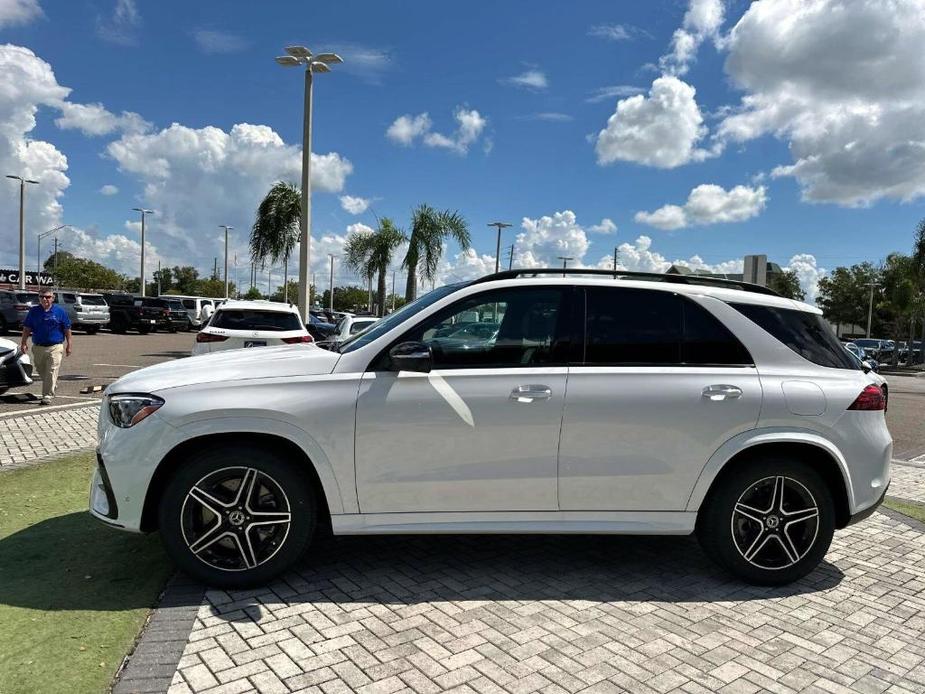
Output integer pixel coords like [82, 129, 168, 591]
[402, 205, 472, 301]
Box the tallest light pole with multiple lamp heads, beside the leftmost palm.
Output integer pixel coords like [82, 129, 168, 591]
[276, 46, 344, 323]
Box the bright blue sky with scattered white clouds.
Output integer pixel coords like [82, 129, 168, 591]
[0, 0, 925, 292]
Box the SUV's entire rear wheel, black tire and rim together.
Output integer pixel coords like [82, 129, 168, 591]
[697, 457, 835, 586]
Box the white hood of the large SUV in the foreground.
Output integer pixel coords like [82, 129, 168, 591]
[107, 345, 340, 393]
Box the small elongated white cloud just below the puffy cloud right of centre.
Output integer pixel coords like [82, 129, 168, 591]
[634, 184, 768, 230]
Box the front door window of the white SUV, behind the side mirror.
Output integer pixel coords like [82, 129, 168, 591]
[377, 287, 567, 369]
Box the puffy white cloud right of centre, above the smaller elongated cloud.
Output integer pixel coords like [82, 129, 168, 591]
[596, 76, 715, 169]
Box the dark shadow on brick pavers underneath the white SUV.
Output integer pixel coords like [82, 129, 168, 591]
[262, 535, 845, 604]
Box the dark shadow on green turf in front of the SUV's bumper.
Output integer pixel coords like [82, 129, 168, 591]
[0, 511, 182, 611]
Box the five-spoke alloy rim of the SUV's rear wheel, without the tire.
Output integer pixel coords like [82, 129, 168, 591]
[731, 475, 819, 570]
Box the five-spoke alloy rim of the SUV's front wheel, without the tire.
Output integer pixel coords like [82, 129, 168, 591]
[180, 467, 292, 571]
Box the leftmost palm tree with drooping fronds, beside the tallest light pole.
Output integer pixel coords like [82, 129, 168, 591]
[250, 181, 302, 300]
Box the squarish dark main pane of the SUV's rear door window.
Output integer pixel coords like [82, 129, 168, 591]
[583, 287, 681, 366]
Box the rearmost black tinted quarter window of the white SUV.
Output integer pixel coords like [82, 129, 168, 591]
[731, 304, 860, 369]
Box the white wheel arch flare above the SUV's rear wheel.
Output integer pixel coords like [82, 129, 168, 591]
[686, 427, 856, 511]
